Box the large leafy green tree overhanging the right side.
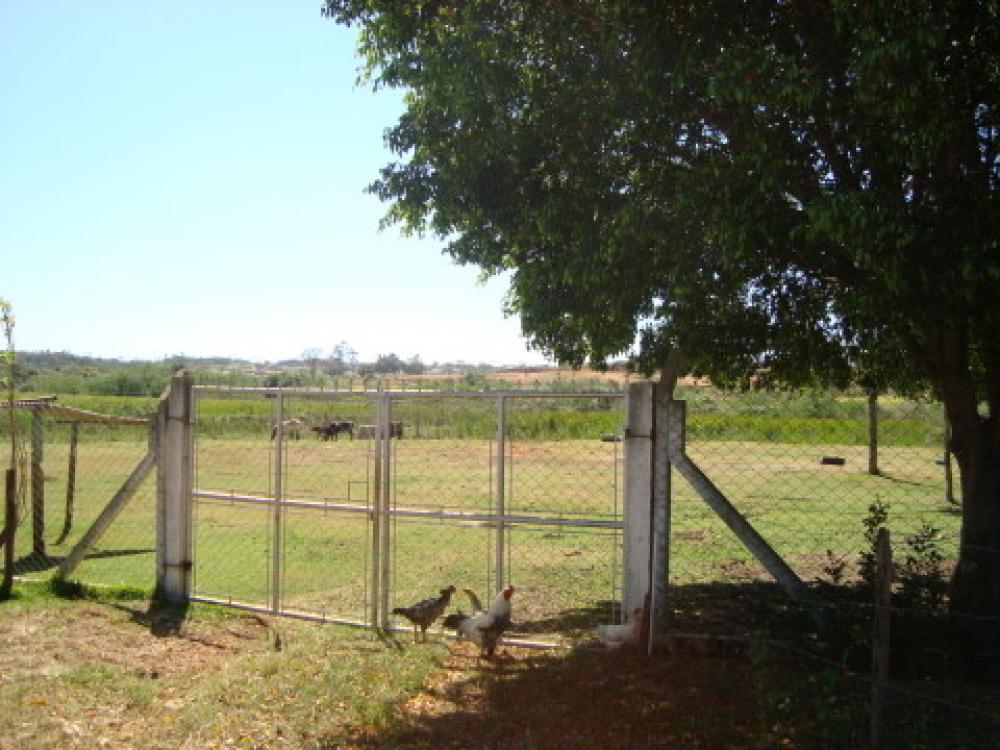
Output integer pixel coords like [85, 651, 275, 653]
[324, 0, 1000, 616]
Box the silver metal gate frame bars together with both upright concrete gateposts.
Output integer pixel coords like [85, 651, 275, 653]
[156, 370, 652, 645]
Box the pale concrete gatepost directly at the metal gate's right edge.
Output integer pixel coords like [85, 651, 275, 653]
[622, 381, 654, 619]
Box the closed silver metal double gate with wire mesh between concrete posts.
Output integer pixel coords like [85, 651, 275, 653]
[192, 386, 625, 641]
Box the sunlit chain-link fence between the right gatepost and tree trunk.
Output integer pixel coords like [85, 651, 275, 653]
[670, 387, 961, 585]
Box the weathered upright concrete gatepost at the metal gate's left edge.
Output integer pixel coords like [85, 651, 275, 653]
[156, 370, 194, 602]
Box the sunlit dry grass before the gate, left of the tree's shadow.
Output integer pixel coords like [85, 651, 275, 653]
[0, 588, 442, 750]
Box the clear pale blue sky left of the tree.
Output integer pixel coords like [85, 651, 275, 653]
[0, 0, 545, 364]
